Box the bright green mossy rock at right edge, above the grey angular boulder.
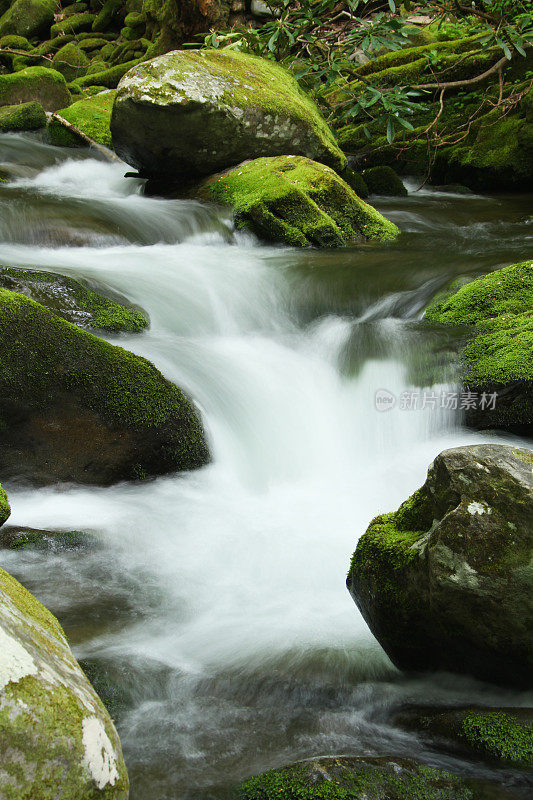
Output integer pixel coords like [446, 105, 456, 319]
[425, 261, 533, 434]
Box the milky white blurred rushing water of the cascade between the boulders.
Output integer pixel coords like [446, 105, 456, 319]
[1, 141, 528, 797]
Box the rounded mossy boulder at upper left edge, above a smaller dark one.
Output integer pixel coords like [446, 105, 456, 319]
[0, 67, 70, 111]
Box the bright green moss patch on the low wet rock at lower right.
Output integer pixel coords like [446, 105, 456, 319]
[461, 711, 533, 767]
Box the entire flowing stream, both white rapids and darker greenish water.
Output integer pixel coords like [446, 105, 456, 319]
[0, 135, 533, 800]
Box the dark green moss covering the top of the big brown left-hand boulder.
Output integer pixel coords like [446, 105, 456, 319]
[0, 290, 195, 432]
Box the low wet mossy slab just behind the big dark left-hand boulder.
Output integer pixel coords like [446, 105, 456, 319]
[0, 267, 149, 333]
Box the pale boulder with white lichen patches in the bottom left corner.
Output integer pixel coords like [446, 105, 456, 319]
[0, 569, 128, 800]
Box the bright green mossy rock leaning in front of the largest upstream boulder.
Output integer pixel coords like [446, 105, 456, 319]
[198, 156, 398, 247]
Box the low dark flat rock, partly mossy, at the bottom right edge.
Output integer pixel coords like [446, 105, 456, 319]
[394, 708, 533, 768]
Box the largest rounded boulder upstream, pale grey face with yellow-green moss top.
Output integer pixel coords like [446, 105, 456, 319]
[111, 50, 346, 181]
